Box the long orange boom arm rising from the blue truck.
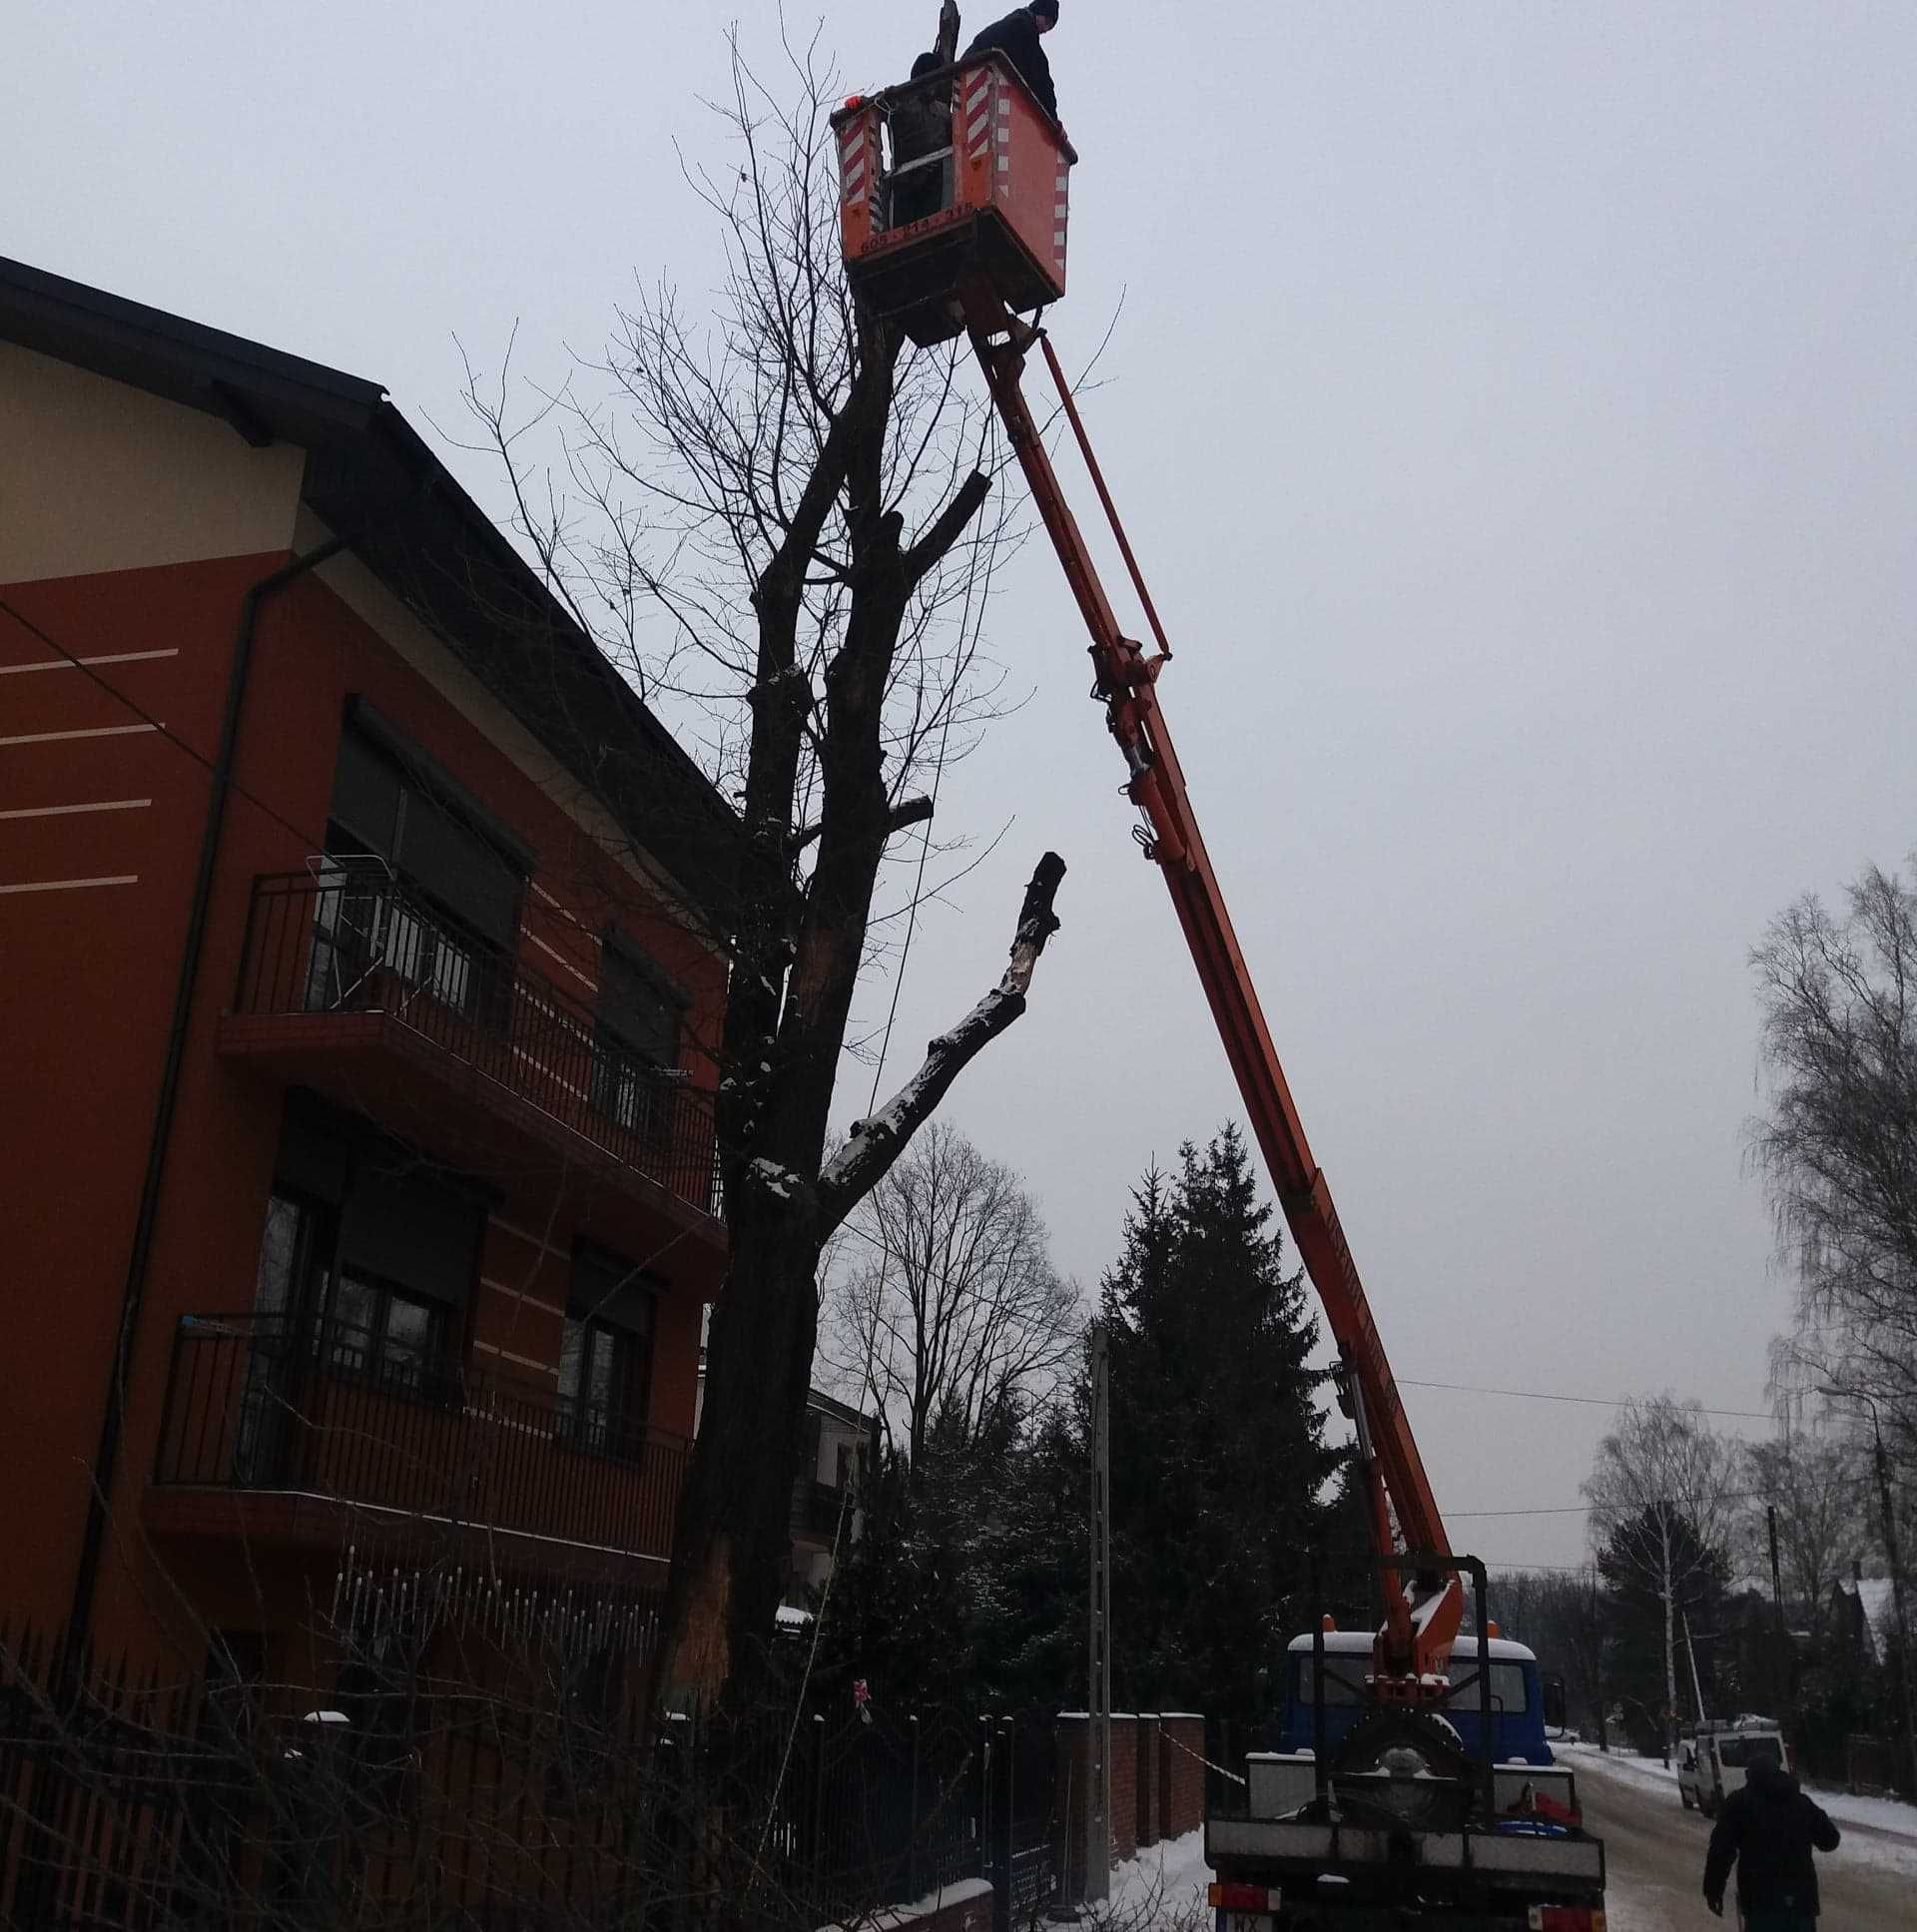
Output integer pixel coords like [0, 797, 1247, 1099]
[960, 283, 1465, 1702]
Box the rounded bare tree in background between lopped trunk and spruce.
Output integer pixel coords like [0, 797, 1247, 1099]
[825, 1120, 1084, 1471]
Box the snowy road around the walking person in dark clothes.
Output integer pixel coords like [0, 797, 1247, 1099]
[1566, 1750, 1917, 1932]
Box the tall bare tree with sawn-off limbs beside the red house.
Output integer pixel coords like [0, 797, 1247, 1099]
[457, 7, 1063, 1704]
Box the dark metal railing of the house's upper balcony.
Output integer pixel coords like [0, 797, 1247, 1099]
[234, 877, 721, 1217]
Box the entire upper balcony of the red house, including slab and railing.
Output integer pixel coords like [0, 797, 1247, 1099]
[221, 862, 725, 1260]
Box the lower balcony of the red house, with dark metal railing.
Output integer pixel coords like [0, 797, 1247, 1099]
[147, 1316, 688, 1581]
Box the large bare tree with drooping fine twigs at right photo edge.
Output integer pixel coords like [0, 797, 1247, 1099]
[1751, 862, 1917, 1476]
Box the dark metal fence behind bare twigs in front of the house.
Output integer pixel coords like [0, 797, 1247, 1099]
[0, 1628, 1061, 1932]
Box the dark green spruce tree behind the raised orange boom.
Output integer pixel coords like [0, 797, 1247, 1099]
[1103, 1126, 1341, 1715]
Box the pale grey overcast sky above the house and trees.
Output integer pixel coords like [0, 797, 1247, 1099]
[0, 0, 1917, 1563]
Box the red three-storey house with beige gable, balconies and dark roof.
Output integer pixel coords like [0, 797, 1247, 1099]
[0, 261, 738, 1680]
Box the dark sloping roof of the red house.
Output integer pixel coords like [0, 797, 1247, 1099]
[0, 257, 742, 932]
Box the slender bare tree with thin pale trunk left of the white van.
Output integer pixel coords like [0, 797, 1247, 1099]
[1583, 1395, 1737, 1762]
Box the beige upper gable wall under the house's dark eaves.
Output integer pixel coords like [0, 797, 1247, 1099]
[0, 341, 306, 583]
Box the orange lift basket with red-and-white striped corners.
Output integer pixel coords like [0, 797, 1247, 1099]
[833, 54, 1078, 345]
